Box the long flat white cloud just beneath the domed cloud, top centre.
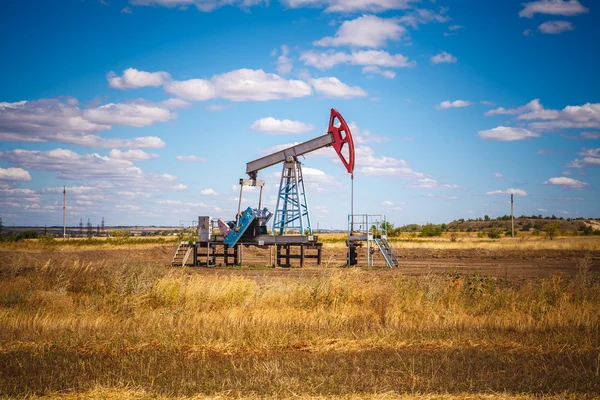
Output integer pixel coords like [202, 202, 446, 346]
[300, 50, 416, 69]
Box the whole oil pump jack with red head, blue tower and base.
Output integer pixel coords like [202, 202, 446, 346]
[173, 108, 354, 267]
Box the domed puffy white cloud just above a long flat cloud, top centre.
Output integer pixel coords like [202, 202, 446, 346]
[313, 15, 406, 47]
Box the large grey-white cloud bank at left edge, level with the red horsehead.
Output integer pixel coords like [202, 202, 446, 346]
[0, 98, 168, 149]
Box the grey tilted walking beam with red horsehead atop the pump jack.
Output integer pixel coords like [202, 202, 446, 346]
[246, 108, 354, 179]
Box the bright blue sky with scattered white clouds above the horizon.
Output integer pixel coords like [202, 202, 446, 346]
[0, 0, 600, 229]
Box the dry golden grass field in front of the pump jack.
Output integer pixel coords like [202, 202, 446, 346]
[0, 237, 600, 399]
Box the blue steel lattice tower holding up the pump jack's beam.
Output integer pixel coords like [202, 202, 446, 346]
[271, 160, 313, 236]
